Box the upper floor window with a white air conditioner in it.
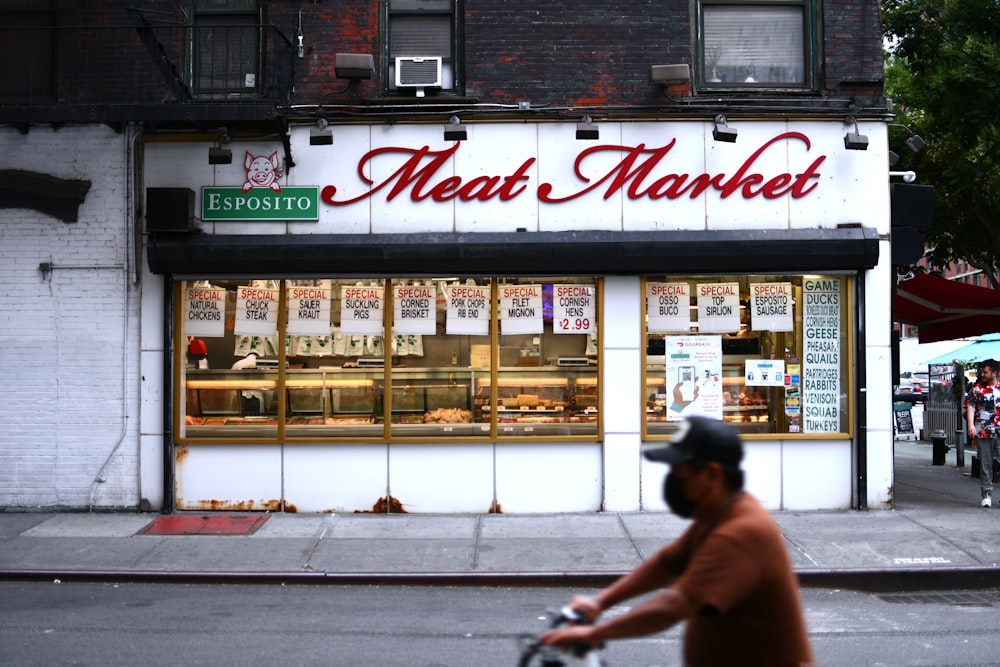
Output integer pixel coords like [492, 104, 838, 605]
[382, 0, 461, 97]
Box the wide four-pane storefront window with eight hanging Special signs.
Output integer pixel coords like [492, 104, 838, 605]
[175, 277, 600, 442]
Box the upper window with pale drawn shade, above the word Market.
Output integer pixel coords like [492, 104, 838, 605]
[698, 0, 816, 88]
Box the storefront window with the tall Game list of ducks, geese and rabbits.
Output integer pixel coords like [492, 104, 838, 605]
[644, 275, 853, 438]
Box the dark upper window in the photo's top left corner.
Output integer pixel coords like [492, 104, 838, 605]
[0, 0, 56, 104]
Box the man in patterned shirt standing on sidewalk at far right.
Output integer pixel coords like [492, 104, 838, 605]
[964, 359, 1000, 507]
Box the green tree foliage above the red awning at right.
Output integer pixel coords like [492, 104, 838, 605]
[882, 0, 1000, 287]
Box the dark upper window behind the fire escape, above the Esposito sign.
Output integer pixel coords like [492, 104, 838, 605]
[191, 0, 263, 99]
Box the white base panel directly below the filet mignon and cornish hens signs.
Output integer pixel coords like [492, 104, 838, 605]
[496, 442, 604, 514]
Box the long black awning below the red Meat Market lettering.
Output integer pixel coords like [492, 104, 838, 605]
[147, 226, 878, 278]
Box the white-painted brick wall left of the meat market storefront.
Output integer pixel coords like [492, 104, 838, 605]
[0, 126, 139, 510]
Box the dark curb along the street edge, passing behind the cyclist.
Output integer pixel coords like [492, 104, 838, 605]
[0, 567, 1000, 593]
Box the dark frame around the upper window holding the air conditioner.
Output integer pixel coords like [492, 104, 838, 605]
[379, 0, 465, 98]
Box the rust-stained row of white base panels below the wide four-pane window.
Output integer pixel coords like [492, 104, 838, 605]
[175, 442, 603, 514]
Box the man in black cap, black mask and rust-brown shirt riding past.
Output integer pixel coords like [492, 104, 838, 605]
[540, 416, 813, 667]
